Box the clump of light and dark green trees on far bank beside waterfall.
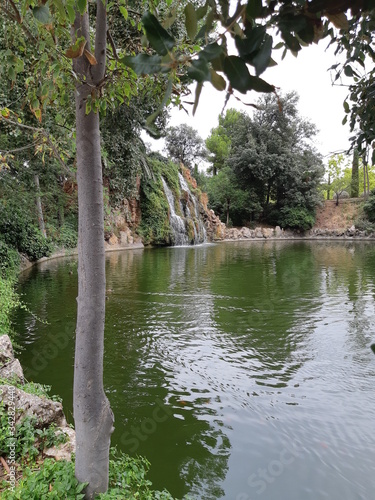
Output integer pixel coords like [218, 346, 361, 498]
[207, 93, 323, 229]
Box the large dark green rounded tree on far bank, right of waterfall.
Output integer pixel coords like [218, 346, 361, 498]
[228, 92, 323, 217]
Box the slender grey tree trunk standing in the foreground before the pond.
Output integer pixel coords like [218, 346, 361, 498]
[73, 0, 113, 499]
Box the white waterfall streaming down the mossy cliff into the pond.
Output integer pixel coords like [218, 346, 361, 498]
[162, 173, 206, 245]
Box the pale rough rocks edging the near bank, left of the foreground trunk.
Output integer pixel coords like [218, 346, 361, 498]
[0, 335, 75, 460]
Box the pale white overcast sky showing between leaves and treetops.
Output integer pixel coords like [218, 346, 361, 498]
[144, 40, 351, 166]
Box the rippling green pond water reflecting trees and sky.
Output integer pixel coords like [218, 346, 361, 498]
[16, 242, 375, 500]
